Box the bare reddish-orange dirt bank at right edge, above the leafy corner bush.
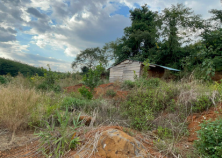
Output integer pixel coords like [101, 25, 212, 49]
[187, 104, 222, 142]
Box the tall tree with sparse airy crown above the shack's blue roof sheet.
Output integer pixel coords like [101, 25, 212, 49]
[156, 4, 204, 68]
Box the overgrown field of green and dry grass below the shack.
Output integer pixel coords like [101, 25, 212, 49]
[0, 75, 222, 157]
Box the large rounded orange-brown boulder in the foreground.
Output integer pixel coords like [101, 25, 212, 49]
[97, 129, 147, 158]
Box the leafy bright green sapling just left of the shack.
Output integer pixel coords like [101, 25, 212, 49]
[83, 63, 105, 92]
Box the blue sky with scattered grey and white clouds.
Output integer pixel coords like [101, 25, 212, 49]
[0, 0, 222, 72]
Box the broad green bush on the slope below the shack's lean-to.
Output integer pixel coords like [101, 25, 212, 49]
[121, 85, 177, 130]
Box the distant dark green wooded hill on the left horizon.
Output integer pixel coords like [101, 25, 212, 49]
[0, 58, 44, 76]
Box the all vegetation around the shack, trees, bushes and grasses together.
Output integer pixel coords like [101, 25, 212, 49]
[0, 4, 222, 158]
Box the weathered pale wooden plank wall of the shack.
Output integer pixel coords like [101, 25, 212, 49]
[109, 60, 141, 82]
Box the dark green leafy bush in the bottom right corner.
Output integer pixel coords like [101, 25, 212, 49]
[195, 119, 222, 158]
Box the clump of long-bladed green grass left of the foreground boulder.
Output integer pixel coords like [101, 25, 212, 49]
[36, 108, 80, 158]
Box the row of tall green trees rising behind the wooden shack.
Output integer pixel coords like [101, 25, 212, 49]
[72, 4, 222, 79]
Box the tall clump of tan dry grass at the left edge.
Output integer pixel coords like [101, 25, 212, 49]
[0, 84, 42, 131]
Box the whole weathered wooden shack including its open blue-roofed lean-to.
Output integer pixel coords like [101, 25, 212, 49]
[109, 59, 180, 82]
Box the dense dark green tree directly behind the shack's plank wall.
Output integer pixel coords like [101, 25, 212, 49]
[110, 5, 159, 62]
